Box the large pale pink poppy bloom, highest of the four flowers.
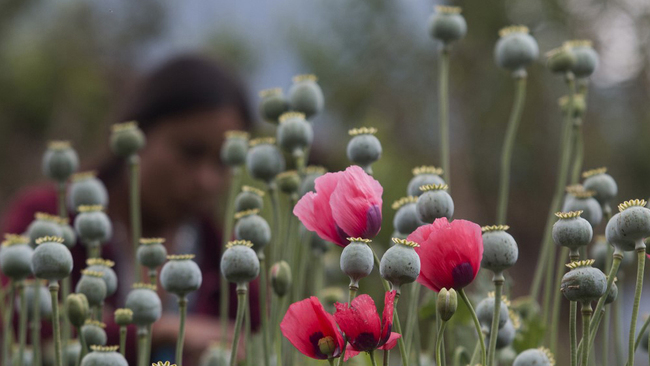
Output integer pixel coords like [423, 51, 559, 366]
[293, 165, 384, 247]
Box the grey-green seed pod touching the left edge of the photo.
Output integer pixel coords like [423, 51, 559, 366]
[0, 235, 34, 281]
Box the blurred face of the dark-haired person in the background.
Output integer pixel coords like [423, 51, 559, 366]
[140, 107, 244, 223]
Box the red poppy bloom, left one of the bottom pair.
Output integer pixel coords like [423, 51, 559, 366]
[280, 296, 345, 360]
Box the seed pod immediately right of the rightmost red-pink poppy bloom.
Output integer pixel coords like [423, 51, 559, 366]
[481, 225, 519, 274]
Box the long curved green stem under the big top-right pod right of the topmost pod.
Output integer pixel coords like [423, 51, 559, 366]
[497, 71, 527, 225]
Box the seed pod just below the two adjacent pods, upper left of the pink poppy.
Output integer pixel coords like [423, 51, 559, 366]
[276, 112, 314, 157]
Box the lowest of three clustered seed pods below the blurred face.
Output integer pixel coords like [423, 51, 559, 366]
[125, 283, 162, 327]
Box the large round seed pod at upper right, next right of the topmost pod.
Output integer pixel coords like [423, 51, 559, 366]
[494, 25, 539, 72]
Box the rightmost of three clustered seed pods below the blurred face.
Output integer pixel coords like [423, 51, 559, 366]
[160, 254, 203, 297]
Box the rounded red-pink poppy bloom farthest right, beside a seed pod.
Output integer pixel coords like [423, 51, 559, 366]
[407, 217, 483, 292]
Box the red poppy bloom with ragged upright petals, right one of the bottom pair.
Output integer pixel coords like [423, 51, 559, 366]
[334, 291, 402, 361]
